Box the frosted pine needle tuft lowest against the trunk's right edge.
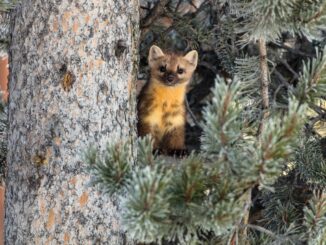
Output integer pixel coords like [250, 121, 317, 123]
[121, 166, 171, 243]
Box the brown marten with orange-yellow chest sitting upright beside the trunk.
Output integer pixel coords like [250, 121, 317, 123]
[137, 45, 198, 154]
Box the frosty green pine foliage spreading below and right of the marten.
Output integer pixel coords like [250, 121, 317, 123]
[86, 0, 326, 244]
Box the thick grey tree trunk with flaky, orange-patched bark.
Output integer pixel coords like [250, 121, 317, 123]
[5, 0, 138, 244]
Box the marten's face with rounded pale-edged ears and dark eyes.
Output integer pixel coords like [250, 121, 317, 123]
[148, 45, 198, 86]
